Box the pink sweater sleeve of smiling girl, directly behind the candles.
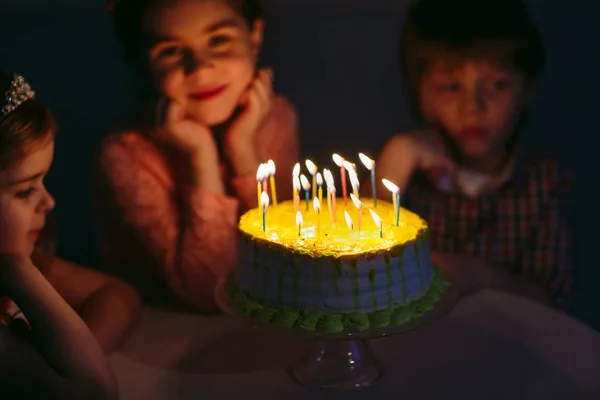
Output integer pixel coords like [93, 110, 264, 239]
[231, 97, 300, 212]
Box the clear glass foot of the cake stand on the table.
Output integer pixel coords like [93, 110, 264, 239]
[289, 340, 384, 390]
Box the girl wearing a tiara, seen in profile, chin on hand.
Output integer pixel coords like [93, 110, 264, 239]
[0, 75, 139, 399]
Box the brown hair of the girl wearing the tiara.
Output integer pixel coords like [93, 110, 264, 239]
[0, 72, 56, 270]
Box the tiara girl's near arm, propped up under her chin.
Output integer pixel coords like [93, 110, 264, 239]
[0, 255, 118, 399]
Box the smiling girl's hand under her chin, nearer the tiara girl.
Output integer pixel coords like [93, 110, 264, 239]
[154, 98, 218, 159]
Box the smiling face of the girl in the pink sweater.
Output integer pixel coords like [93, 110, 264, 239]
[146, 0, 263, 126]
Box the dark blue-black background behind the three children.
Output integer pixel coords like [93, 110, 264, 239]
[0, 0, 600, 329]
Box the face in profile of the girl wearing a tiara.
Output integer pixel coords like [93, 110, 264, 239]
[0, 140, 54, 254]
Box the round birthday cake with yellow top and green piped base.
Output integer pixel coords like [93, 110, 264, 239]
[225, 192, 447, 333]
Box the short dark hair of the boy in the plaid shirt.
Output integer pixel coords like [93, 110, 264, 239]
[399, 0, 546, 115]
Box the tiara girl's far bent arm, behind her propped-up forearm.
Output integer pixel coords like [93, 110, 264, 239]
[36, 258, 141, 353]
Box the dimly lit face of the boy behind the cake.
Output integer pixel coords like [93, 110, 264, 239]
[419, 60, 531, 161]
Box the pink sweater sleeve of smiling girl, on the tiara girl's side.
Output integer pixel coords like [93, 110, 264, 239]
[100, 137, 238, 310]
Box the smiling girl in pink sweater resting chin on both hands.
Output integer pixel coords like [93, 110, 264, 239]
[99, 0, 298, 310]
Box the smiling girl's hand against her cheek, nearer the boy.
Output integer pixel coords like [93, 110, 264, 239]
[225, 69, 273, 159]
